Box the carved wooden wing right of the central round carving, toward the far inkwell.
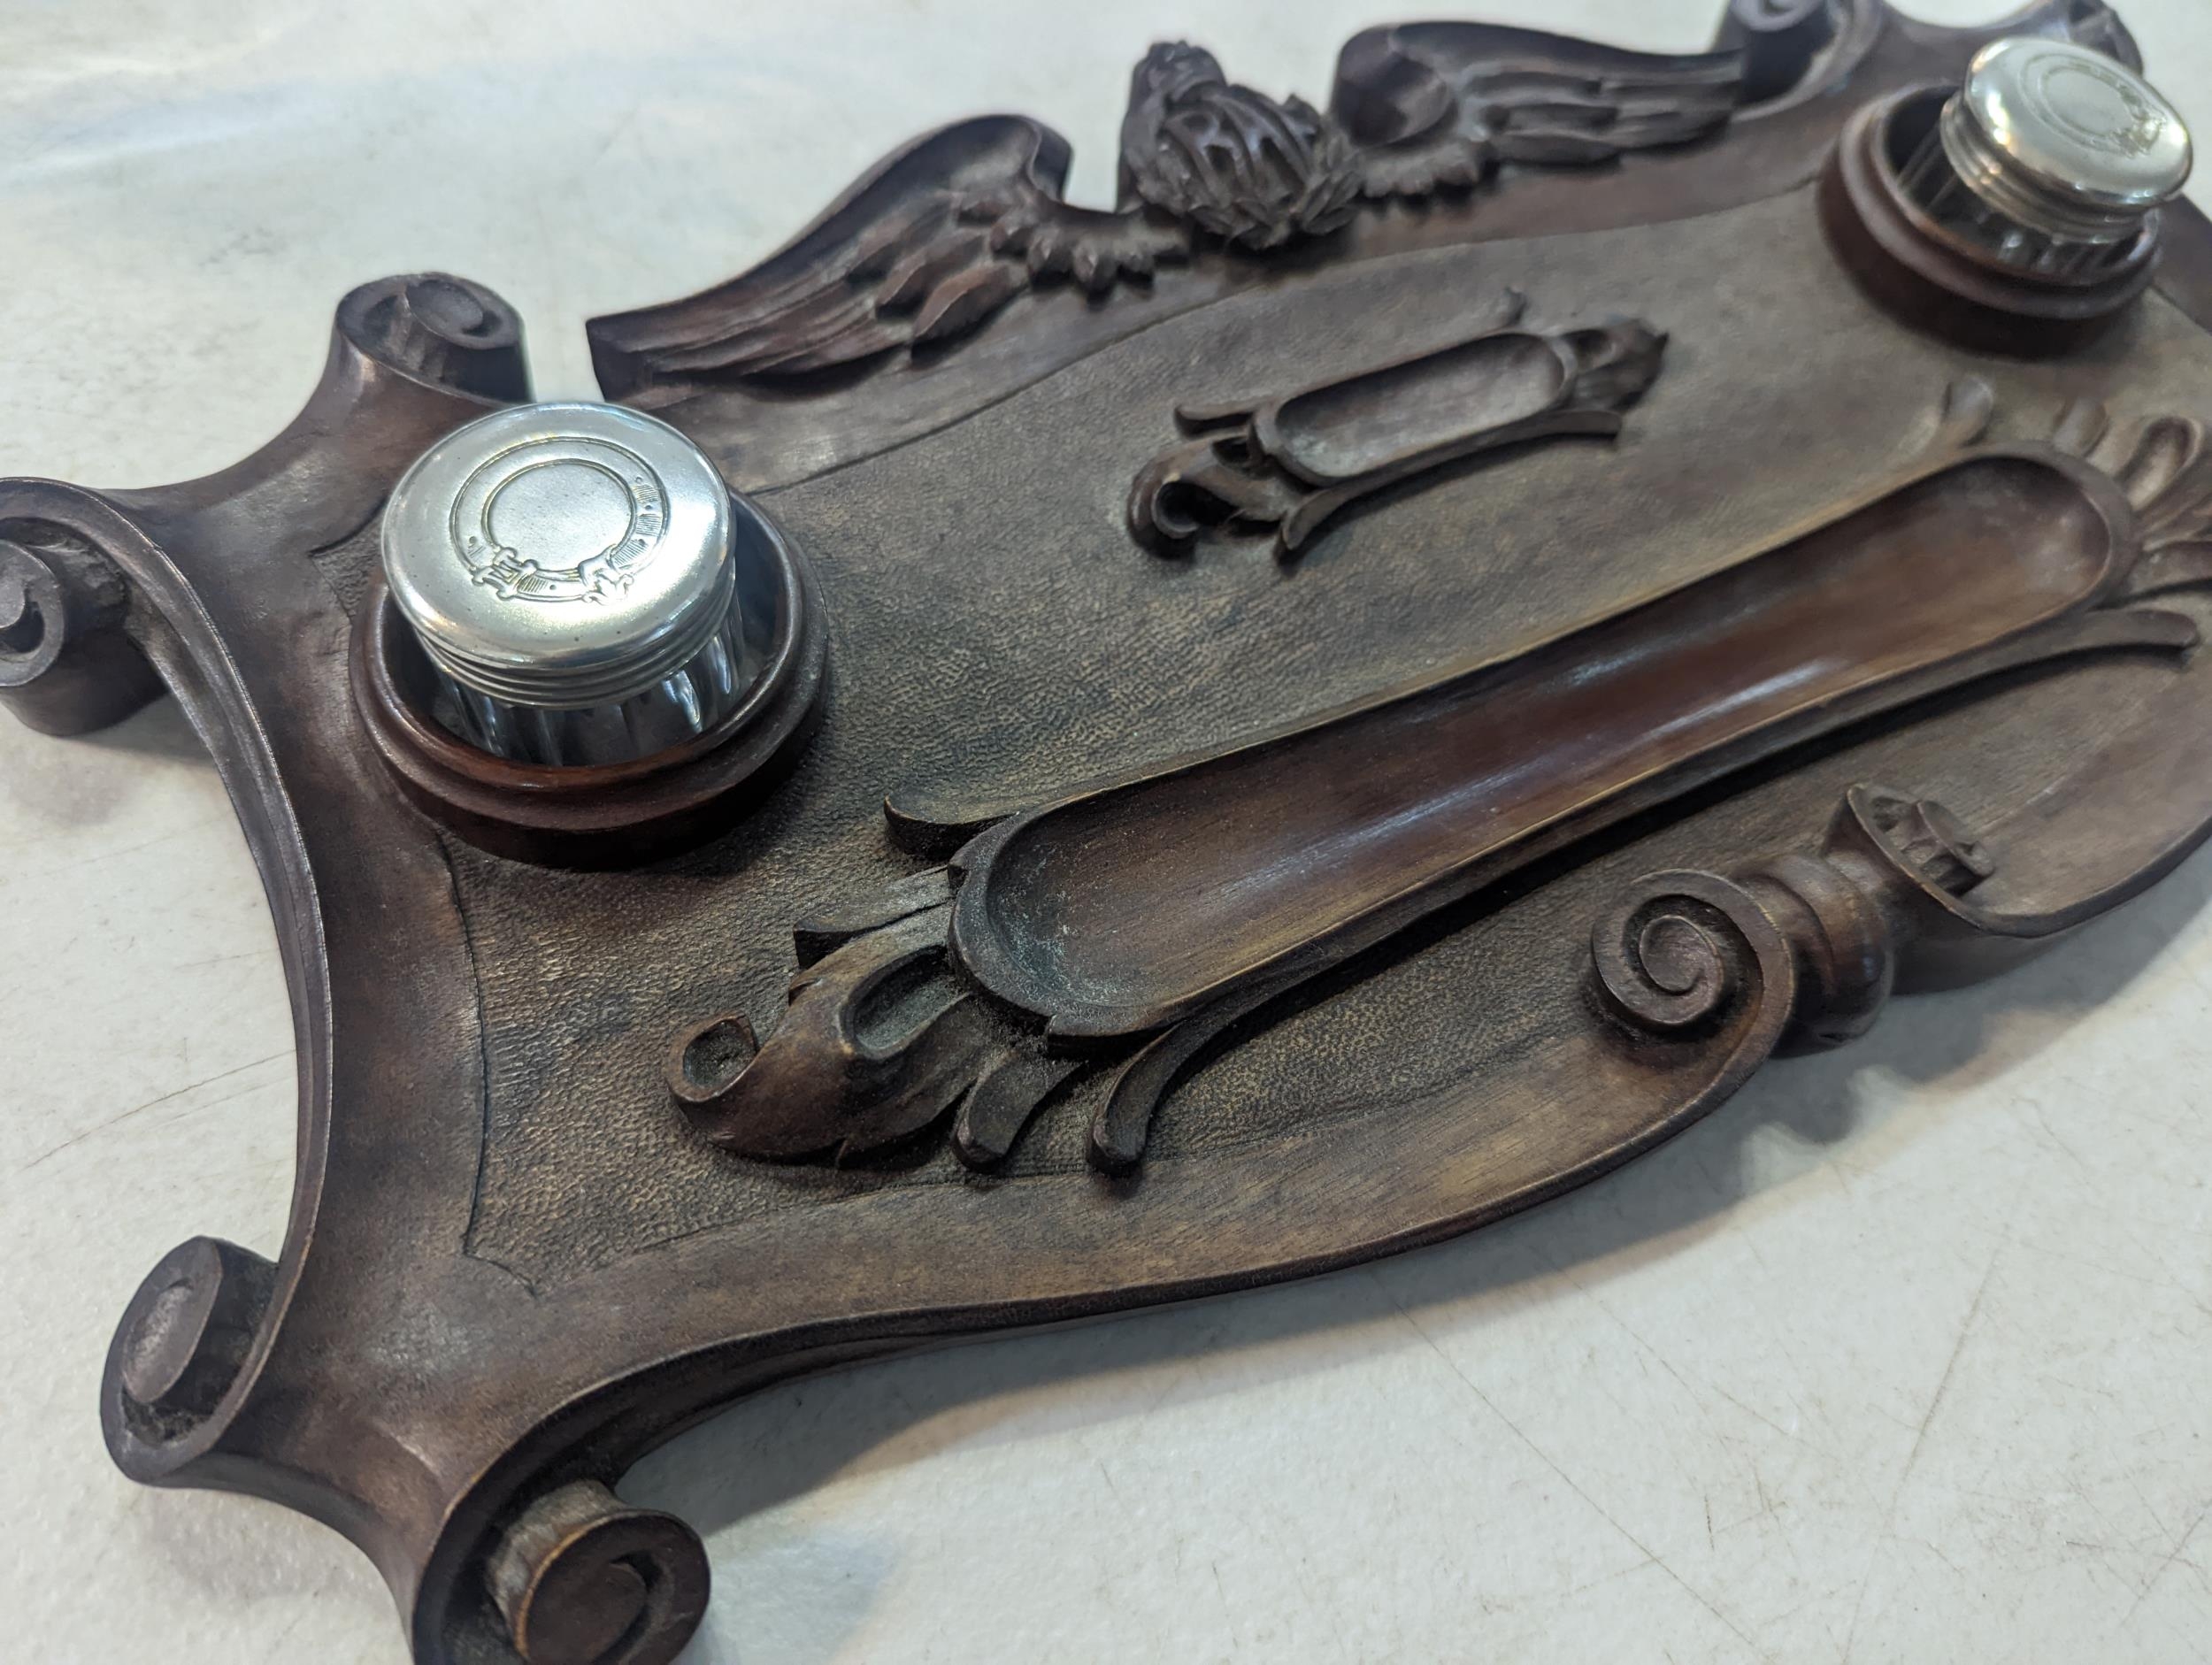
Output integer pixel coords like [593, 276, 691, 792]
[1332, 22, 1743, 196]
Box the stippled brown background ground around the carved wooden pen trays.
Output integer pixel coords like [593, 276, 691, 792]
[451, 192, 2212, 1283]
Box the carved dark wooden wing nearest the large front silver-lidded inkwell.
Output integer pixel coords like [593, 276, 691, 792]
[591, 115, 1190, 395]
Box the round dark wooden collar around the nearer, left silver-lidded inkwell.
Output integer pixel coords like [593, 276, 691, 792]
[352, 493, 826, 867]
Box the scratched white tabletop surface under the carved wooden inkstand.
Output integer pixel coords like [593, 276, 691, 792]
[0, 0, 2212, 1665]
